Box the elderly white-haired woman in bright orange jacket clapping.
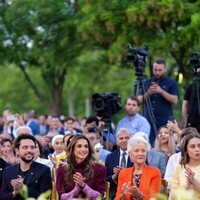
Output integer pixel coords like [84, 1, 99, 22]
[115, 136, 161, 200]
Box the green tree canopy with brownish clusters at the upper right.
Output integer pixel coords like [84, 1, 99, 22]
[79, 0, 200, 85]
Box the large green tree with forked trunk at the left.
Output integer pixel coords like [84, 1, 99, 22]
[0, 0, 80, 113]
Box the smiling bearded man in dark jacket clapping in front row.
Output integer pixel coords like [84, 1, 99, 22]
[0, 134, 52, 200]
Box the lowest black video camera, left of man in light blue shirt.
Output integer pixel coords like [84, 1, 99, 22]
[92, 92, 122, 120]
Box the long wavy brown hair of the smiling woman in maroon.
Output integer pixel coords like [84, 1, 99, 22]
[64, 135, 95, 184]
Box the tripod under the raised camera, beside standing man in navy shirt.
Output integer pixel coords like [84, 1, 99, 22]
[132, 76, 157, 137]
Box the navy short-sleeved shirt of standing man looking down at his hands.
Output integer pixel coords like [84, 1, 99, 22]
[140, 76, 179, 127]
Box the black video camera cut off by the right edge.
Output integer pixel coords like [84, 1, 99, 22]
[189, 52, 200, 76]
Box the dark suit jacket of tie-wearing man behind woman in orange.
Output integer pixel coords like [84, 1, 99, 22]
[105, 149, 133, 199]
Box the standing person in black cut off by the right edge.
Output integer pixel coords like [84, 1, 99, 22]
[182, 66, 200, 132]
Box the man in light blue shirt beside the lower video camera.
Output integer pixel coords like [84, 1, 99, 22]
[116, 96, 150, 137]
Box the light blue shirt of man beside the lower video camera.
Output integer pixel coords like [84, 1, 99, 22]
[116, 113, 150, 137]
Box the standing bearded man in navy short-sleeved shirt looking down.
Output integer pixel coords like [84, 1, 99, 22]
[138, 58, 179, 145]
